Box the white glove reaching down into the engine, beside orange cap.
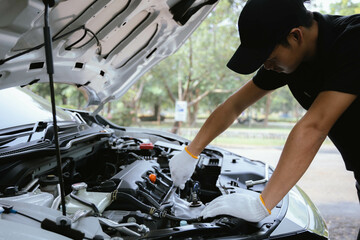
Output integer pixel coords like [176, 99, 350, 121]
[169, 147, 197, 189]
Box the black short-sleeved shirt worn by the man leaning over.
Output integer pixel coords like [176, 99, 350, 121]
[253, 12, 360, 174]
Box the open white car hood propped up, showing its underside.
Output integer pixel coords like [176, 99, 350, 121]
[0, 0, 217, 109]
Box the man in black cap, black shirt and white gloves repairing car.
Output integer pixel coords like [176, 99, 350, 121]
[169, 0, 360, 227]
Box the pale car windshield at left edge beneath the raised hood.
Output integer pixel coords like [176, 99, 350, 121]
[0, 88, 73, 129]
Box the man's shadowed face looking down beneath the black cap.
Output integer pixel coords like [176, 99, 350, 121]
[264, 44, 303, 74]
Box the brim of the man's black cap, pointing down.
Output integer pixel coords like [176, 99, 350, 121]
[226, 45, 272, 74]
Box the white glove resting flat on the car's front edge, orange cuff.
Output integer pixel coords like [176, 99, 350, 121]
[201, 192, 271, 222]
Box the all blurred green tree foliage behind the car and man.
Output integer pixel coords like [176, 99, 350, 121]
[29, 0, 360, 126]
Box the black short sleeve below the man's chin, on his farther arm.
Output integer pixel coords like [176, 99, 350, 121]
[253, 66, 287, 90]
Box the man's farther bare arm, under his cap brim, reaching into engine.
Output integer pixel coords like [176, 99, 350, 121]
[187, 80, 270, 156]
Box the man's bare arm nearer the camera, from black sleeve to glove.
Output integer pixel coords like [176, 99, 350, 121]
[262, 91, 357, 209]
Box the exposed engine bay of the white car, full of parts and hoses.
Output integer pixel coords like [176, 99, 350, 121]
[0, 123, 286, 239]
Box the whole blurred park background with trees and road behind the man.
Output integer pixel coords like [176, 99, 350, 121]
[30, 0, 360, 139]
